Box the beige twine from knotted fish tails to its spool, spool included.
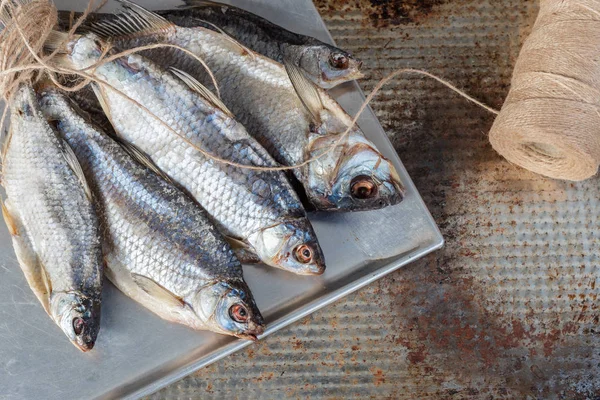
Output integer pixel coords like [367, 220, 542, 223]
[0, 0, 600, 181]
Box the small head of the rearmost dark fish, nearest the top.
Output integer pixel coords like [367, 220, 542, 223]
[289, 44, 364, 89]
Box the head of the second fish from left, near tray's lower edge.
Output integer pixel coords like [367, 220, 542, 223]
[194, 280, 265, 340]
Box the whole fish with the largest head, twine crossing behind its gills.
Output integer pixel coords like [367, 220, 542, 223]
[89, 5, 403, 211]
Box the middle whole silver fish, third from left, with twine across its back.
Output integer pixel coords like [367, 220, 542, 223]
[55, 35, 324, 274]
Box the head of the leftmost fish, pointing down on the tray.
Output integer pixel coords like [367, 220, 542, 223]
[50, 292, 100, 352]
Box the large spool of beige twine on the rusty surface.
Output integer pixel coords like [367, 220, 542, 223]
[490, 0, 600, 181]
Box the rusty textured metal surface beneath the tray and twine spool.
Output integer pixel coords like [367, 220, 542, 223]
[152, 0, 600, 399]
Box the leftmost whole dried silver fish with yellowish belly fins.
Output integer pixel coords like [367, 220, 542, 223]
[2, 86, 103, 351]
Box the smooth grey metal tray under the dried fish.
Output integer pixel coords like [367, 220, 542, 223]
[0, 0, 443, 400]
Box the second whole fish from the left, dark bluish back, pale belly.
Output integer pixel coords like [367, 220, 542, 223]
[40, 88, 264, 339]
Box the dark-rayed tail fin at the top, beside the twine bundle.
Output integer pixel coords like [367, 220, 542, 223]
[88, 0, 175, 39]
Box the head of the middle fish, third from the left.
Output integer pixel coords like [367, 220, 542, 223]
[249, 217, 325, 275]
